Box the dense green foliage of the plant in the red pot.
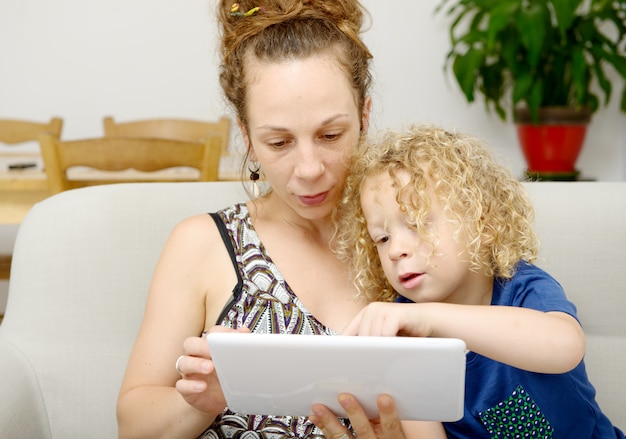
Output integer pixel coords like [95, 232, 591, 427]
[438, 0, 626, 119]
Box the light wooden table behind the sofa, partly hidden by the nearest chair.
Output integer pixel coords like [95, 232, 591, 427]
[0, 152, 241, 225]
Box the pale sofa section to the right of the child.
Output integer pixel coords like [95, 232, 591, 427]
[526, 182, 626, 431]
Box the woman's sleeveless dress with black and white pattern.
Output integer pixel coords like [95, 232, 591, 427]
[199, 203, 349, 439]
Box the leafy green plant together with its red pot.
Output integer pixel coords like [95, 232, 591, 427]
[437, 0, 626, 180]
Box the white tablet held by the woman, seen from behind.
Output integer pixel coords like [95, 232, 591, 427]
[206, 332, 466, 421]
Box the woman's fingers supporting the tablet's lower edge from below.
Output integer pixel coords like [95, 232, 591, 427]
[309, 393, 405, 439]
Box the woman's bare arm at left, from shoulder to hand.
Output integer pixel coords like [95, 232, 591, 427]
[117, 215, 237, 438]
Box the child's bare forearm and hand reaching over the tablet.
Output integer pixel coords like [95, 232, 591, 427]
[343, 302, 585, 373]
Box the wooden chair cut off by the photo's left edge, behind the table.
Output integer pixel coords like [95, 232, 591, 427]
[0, 117, 63, 279]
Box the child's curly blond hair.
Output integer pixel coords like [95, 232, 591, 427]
[334, 124, 539, 301]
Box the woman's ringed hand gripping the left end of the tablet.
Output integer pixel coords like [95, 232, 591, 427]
[176, 326, 249, 416]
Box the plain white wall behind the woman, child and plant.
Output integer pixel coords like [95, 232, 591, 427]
[0, 0, 626, 180]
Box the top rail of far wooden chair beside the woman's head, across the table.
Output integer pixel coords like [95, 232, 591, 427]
[103, 116, 231, 154]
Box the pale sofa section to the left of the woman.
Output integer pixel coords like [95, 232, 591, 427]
[0, 182, 247, 439]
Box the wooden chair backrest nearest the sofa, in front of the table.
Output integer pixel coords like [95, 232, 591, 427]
[39, 133, 222, 193]
